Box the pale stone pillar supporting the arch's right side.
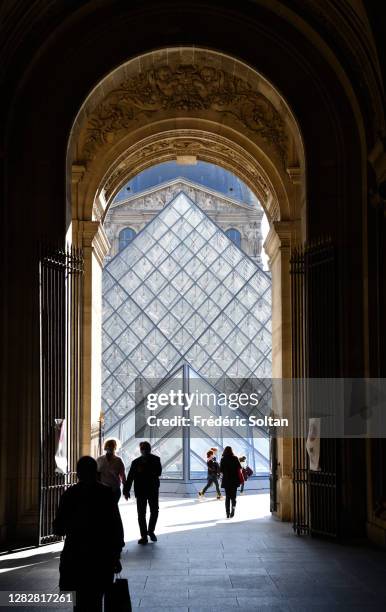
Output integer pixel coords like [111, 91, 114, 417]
[264, 221, 299, 521]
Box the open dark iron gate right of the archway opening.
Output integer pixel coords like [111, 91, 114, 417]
[291, 241, 339, 537]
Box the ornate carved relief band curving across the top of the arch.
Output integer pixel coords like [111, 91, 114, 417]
[83, 64, 287, 161]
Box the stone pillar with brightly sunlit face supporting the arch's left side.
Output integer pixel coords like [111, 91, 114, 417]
[72, 221, 110, 455]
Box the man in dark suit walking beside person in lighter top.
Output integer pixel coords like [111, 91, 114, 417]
[123, 442, 162, 544]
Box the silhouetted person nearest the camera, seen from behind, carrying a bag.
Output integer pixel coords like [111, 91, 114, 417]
[54, 457, 125, 612]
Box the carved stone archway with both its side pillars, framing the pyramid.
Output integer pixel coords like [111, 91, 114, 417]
[67, 47, 305, 520]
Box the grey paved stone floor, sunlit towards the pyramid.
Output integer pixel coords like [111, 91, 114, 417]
[0, 493, 386, 612]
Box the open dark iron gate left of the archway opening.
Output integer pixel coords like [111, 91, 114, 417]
[39, 247, 83, 544]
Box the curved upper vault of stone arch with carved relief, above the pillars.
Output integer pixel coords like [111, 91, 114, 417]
[69, 47, 304, 224]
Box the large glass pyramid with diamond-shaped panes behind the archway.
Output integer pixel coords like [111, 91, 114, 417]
[102, 192, 272, 478]
